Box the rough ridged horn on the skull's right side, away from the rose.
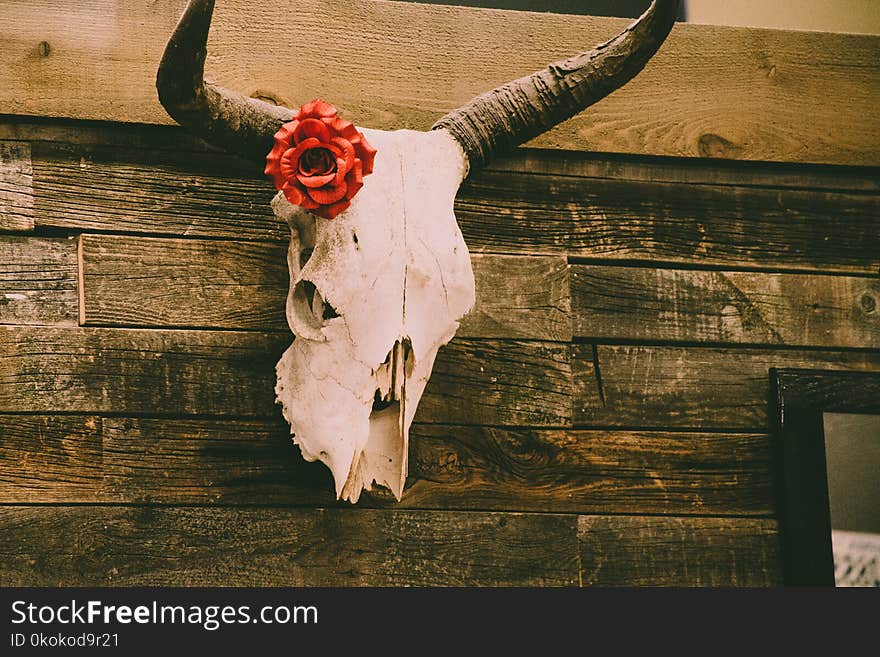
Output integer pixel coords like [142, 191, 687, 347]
[432, 0, 679, 168]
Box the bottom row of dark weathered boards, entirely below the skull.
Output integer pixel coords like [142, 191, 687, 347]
[0, 506, 779, 586]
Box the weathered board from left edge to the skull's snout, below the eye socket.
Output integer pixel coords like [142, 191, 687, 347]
[0, 327, 290, 416]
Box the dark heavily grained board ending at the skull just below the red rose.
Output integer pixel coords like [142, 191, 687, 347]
[33, 143, 289, 241]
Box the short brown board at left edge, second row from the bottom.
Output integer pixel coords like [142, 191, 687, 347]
[0, 415, 105, 504]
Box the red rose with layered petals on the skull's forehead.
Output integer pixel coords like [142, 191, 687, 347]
[265, 100, 376, 219]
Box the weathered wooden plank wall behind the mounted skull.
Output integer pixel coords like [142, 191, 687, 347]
[0, 0, 880, 586]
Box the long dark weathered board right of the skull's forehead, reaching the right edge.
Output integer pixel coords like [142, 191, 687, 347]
[456, 171, 880, 274]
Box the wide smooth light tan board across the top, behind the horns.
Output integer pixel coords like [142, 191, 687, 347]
[0, 0, 880, 164]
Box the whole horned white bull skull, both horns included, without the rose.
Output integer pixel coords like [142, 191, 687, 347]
[157, 0, 678, 502]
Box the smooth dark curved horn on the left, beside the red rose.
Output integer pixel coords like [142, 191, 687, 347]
[156, 0, 294, 163]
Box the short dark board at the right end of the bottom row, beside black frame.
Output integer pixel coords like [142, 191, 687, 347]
[578, 516, 781, 587]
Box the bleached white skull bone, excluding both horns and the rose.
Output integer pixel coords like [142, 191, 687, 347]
[272, 130, 475, 502]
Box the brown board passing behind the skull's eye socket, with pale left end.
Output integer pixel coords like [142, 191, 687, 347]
[81, 235, 571, 342]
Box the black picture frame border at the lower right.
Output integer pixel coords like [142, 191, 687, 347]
[770, 369, 880, 586]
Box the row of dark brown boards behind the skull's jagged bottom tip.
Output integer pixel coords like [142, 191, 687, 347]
[0, 415, 773, 515]
